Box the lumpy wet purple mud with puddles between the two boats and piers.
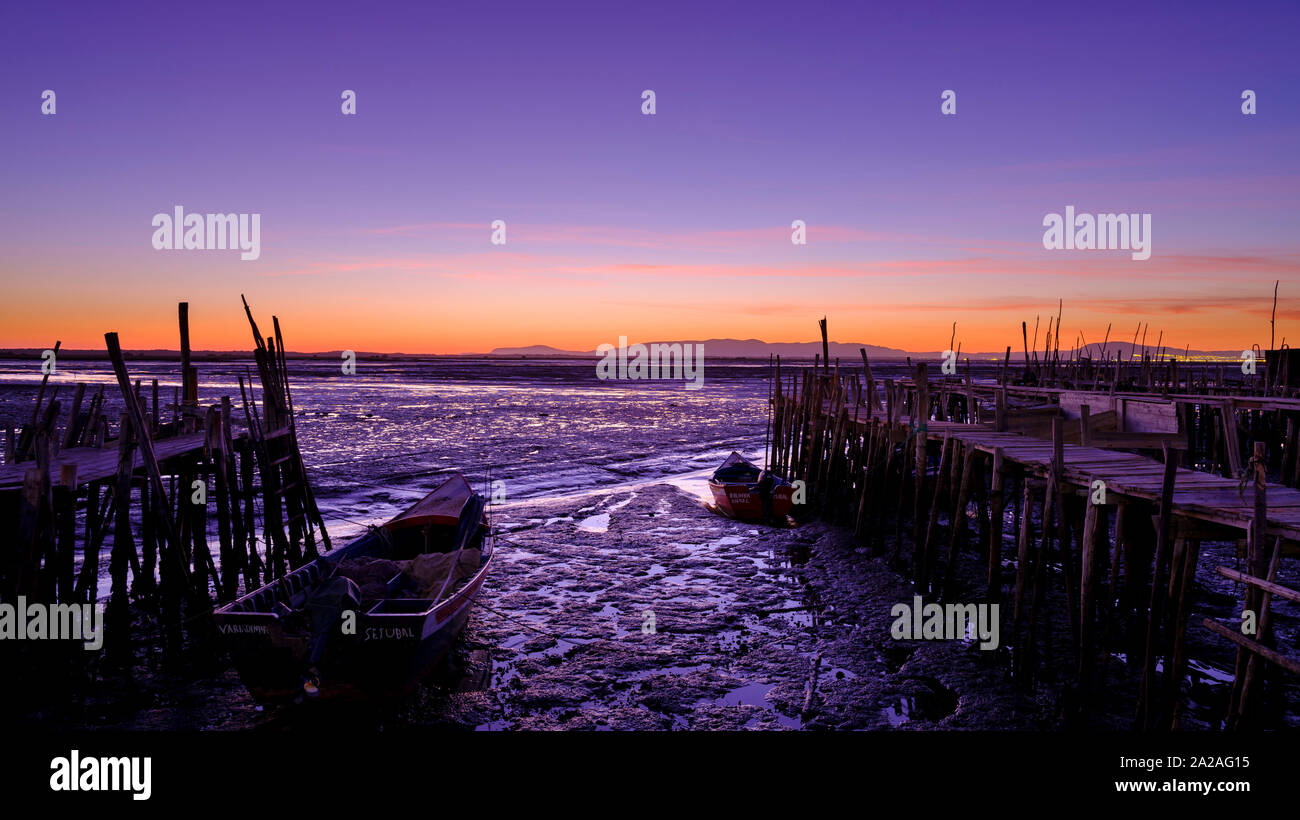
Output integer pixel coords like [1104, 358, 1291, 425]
[387, 485, 1048, 730]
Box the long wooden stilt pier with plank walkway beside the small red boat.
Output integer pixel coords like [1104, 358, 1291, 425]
[766, 326, 1300, 730]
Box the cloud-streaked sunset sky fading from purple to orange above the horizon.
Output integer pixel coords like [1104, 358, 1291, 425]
[0, 3, 1300, 352]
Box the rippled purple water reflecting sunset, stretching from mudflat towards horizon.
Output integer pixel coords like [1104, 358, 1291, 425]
[0, 359, 790, 591]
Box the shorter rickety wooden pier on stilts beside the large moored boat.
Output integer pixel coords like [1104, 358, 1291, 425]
[0, 303, 329, 686]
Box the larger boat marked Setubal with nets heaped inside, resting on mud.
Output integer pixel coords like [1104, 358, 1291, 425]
[213, 474, 494, 703]
